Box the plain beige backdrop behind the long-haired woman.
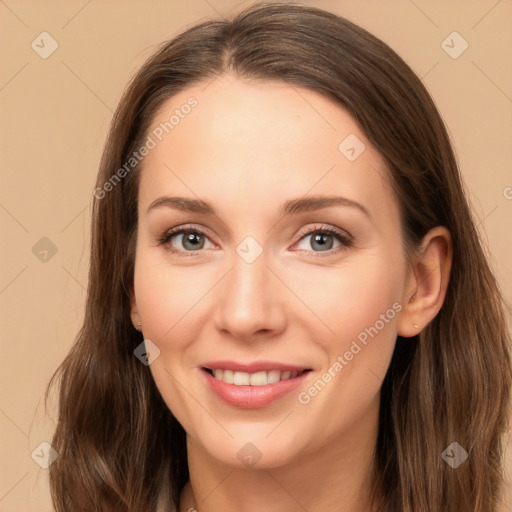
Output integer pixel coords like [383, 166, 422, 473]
[0, 0, 512, 512]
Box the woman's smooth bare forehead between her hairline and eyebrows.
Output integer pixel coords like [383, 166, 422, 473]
[139, 76, 396, 224]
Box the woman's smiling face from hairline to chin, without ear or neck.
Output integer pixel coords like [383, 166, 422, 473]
[133, 76, 408, 467]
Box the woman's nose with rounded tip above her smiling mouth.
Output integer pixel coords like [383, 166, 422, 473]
[214, 247, 286, 341]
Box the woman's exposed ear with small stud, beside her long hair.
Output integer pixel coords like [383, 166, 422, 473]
[398, 226, 453, 338]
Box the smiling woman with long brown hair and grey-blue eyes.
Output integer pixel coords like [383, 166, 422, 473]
[46, 4, 512, 512]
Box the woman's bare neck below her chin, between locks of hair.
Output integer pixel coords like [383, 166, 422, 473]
[180, 399, 379, 512]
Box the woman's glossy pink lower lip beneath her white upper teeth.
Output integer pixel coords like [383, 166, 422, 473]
[201, 368, 311, 409]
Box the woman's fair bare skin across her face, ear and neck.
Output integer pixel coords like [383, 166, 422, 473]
[132, 75, 451, 512]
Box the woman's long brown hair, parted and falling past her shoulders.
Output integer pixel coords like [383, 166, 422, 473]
[47, 3, 512, 512]
